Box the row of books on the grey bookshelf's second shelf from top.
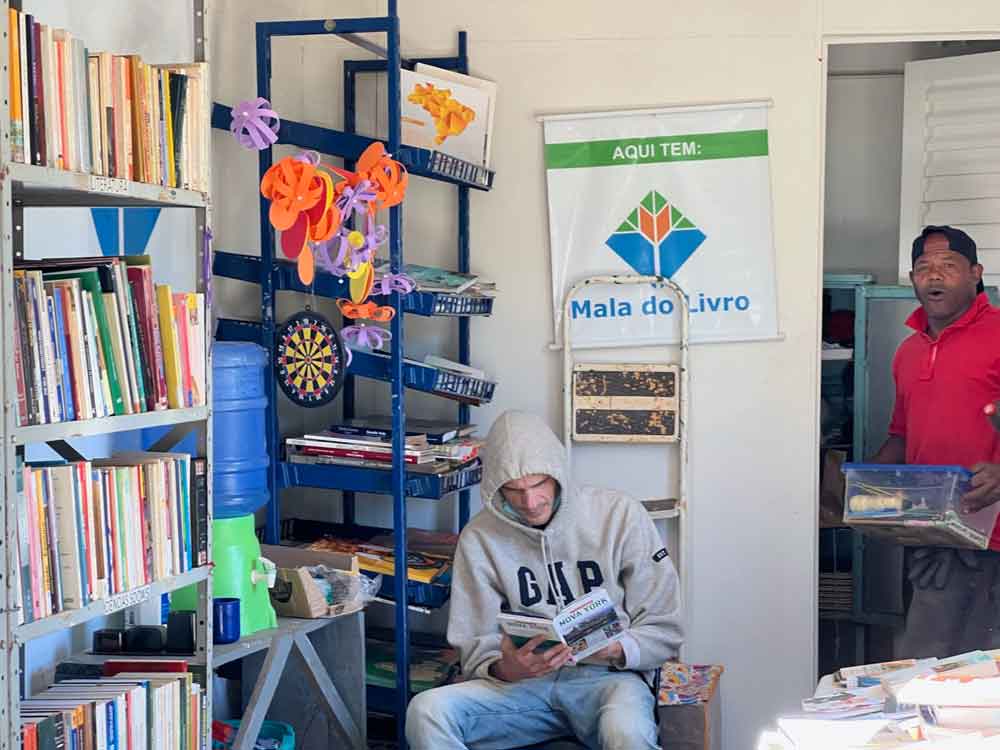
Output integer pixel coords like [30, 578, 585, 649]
[14, 256, 207, 426]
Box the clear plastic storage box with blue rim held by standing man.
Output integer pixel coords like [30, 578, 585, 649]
[843, 464, 1000, 549]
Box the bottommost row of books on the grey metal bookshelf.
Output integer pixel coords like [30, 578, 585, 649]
[20, 660, 202, 750]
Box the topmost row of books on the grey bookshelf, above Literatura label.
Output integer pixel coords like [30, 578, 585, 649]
[8, 8, 210, 191]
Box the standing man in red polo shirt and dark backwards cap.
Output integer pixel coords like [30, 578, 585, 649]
[874, 226, 1000, 657]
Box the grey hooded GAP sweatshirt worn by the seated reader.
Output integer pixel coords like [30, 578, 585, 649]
[448, 411, 683, 678]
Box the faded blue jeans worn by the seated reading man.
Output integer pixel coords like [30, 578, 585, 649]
[406, 665, 660, 750]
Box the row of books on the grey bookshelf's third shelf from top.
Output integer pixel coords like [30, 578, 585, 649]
[14, 452, 208, 623]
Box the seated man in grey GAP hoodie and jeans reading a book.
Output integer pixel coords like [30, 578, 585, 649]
[406, 411, 683, 750]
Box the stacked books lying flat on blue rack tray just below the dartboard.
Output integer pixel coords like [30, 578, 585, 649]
[285, 416, 482, 474]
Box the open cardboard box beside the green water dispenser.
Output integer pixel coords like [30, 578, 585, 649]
[260, 544, 361, 619]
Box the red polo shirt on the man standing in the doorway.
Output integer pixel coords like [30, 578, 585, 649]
[889, 294, 1000, 549]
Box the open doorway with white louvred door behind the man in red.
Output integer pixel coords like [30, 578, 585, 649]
[817, 39, 1000, 675]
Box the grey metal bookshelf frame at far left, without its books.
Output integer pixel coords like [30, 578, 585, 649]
[0, 0, 212, 750]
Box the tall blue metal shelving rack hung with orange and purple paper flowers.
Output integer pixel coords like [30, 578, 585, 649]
[212, 8, 494, 748]
